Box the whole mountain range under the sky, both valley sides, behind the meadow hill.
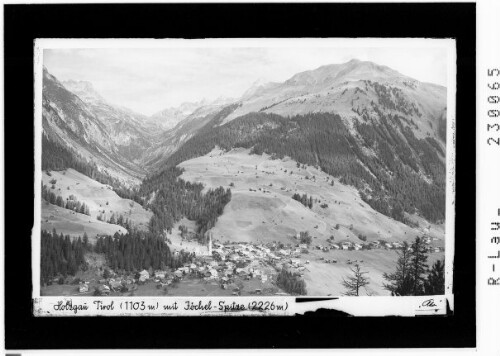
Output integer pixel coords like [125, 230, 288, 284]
[42, 60, 446, 227]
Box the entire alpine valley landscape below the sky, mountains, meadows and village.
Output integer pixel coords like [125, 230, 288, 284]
[41, 60, 447, 296]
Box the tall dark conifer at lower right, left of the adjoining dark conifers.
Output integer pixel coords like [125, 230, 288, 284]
[384, 241, 413, 296]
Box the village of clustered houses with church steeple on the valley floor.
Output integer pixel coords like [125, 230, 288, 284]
[47, 227, 443, 296]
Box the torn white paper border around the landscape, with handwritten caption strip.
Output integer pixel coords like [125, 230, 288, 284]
[32, 38, 456, 316]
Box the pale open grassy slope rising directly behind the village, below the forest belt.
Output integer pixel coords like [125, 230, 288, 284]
[179, 149, 444, 245]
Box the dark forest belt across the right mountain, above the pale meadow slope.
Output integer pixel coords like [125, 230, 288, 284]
[158, 112, 445, 222]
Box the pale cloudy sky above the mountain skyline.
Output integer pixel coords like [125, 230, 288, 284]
[44, 43, 447, 115]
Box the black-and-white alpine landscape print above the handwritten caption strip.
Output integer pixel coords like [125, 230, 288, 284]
[33, 39, 456, 314]
